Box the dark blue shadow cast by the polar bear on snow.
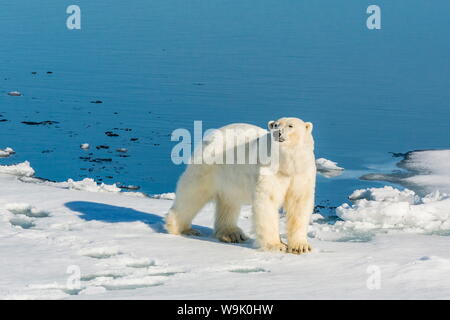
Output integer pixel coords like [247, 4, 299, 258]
[64, 201, 253, 247]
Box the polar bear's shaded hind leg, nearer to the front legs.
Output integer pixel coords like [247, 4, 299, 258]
[214, 196, 248, 243]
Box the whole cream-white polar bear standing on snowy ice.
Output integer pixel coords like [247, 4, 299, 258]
[166, 118, 316, 254]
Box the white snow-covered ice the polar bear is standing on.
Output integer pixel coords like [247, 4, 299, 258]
[0, 155, 450, 299]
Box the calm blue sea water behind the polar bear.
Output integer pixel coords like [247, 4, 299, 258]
[0, 0, 450, 210]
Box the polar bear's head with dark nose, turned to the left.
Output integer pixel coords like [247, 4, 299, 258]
[268, 118, 314, 148]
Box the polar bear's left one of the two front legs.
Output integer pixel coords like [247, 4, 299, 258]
[252, 193, 287, 252]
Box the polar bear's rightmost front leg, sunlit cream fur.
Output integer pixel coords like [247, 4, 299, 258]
[285, 184, 314, 254]
